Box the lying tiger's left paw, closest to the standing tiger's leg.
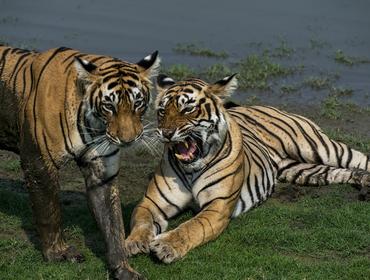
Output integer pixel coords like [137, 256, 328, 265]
[125, 230, 154, 256]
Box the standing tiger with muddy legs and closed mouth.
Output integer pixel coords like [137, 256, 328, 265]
[0, 46, 159, 279]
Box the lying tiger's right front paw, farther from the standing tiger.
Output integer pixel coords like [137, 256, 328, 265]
[149, 233, 186, 263]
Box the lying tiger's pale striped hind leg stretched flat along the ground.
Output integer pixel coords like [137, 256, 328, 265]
[277, 159, 370, 200]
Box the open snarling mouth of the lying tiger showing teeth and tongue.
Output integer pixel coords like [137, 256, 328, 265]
[171, 137, 201, 163]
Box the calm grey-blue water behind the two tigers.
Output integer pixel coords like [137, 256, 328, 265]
[0, 0, 370, 106]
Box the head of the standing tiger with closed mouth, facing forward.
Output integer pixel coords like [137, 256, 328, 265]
[74, 51, 160, 145]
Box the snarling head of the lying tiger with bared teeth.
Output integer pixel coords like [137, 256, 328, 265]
[156, 74, 237, 168]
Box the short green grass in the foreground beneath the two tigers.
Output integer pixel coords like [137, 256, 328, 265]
[0, 182, 370, 280]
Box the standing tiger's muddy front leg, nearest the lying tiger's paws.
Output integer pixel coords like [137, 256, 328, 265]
[78, 153, 140, 279]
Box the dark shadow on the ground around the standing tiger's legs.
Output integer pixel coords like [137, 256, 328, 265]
[0, 178, 136, 264]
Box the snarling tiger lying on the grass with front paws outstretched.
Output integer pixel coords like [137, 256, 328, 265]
[126, 75, 370, 263]
